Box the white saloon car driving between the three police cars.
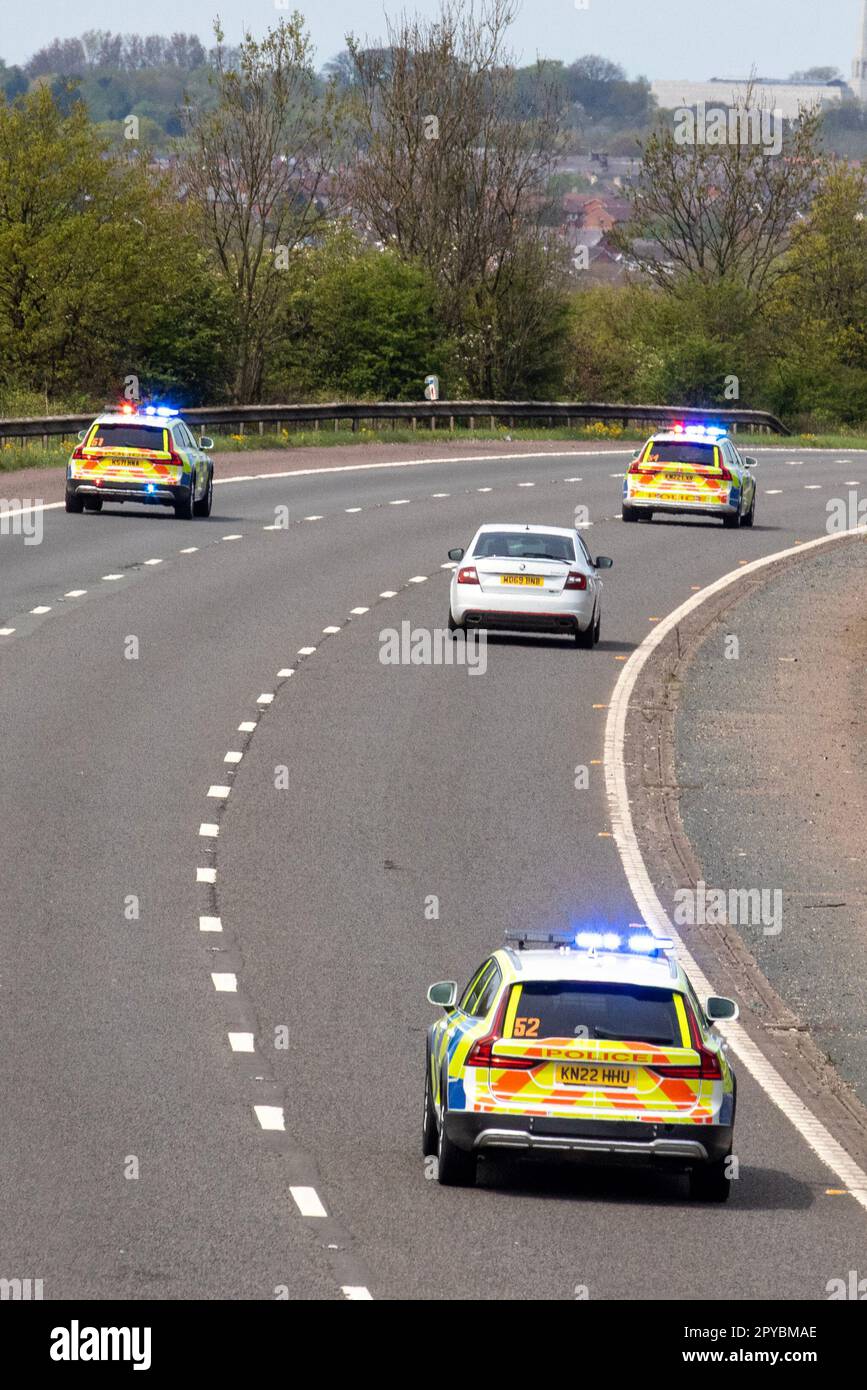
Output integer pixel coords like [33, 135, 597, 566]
[449, 523, 614, 648]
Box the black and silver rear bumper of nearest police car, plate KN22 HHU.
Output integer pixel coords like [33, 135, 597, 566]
[446, 1111, 734, 1166]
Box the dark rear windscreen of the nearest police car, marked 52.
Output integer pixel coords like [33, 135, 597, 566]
[517, 980, 681, 1047]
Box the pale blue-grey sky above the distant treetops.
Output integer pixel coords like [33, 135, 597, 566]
[0, 0, 861, 79]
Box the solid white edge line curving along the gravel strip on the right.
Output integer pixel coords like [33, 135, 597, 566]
[604, 527, 867, 1211]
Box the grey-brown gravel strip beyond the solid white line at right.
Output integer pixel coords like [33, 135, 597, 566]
[677, 542, 867, 1102]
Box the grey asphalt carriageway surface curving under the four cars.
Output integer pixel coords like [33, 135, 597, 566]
[0, 445, 867, 1300]
